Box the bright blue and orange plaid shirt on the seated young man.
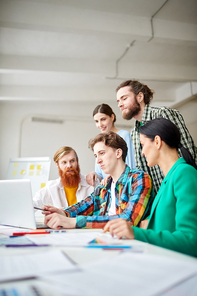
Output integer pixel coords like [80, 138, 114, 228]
[64, 165, 153, 228]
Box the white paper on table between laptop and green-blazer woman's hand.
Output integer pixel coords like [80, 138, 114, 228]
[26, 231, 122, 246]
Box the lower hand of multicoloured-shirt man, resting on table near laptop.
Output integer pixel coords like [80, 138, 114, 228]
[44, 213, 76, 229]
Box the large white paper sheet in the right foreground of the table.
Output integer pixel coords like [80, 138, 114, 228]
[42, 252, 197, 296]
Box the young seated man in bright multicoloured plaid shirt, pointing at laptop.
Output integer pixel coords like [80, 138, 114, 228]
[43, 132, 153, 229]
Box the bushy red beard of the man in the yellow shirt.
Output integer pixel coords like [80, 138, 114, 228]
[59, 165, 81, 188]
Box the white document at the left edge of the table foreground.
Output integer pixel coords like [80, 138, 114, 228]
[0, 249, 77, 282]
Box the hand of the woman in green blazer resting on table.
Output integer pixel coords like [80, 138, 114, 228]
[104, 218, 135, 239]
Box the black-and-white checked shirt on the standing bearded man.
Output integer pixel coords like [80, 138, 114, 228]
[131, 105, 197, 193]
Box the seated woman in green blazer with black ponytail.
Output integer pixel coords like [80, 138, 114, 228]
[104, 118, 197, 257]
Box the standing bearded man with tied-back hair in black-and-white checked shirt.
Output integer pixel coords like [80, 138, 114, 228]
[116, 80, 197, 194]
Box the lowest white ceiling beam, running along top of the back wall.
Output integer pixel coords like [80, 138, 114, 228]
[0, 81, 175, 105]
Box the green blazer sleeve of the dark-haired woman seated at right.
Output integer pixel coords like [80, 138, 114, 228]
[133, 166, 197, 257]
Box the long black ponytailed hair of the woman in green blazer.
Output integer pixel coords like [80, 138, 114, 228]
[139, 118, 197, 169]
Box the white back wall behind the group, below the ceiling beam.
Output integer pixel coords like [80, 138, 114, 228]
[0, 98, 197, 179]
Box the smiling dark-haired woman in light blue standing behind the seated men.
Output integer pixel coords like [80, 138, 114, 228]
[86, 104, 136, 185]
